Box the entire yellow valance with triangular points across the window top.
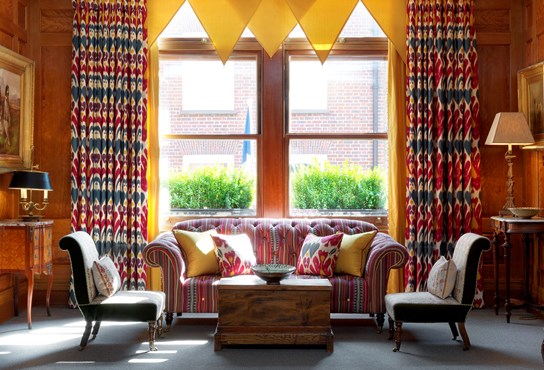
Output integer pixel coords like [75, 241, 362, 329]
[147, 0, 406, 63]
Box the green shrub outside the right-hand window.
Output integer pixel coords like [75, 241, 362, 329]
[291, 161, 386, 209]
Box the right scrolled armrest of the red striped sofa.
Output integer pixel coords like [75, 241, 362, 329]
[364, 232, 408, 313]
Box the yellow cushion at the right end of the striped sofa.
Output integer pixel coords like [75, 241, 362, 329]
[334, 230, 377, 276]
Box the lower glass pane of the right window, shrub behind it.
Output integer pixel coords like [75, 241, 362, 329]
[289, 139, 388, 216]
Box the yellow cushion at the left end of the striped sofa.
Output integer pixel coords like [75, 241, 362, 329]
[173, 229, 219, 277]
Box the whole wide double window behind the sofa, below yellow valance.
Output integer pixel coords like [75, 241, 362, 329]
[159, 2, 388, 230]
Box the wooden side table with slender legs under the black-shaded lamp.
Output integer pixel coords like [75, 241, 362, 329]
[0, 220, 53, 329]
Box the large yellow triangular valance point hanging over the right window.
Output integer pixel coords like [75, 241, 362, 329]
[286, 0, 359, 63]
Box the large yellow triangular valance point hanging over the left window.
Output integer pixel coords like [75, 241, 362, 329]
[189, 0, 261, 64]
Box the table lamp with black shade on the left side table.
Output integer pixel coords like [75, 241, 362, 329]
[9, 171, 53, 222]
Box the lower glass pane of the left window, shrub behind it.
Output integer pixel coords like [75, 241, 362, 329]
[159, 139, 257, 215]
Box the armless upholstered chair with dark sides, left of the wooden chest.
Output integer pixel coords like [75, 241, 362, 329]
[59, 231, 165, 351]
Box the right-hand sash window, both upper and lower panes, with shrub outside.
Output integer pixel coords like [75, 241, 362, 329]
[286, 55, 388, 216]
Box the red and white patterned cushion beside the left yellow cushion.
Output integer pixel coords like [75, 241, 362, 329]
[212, 234, 256, 277]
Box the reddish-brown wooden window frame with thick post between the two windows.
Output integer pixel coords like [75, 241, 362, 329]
[158, 37, 388, 230]
